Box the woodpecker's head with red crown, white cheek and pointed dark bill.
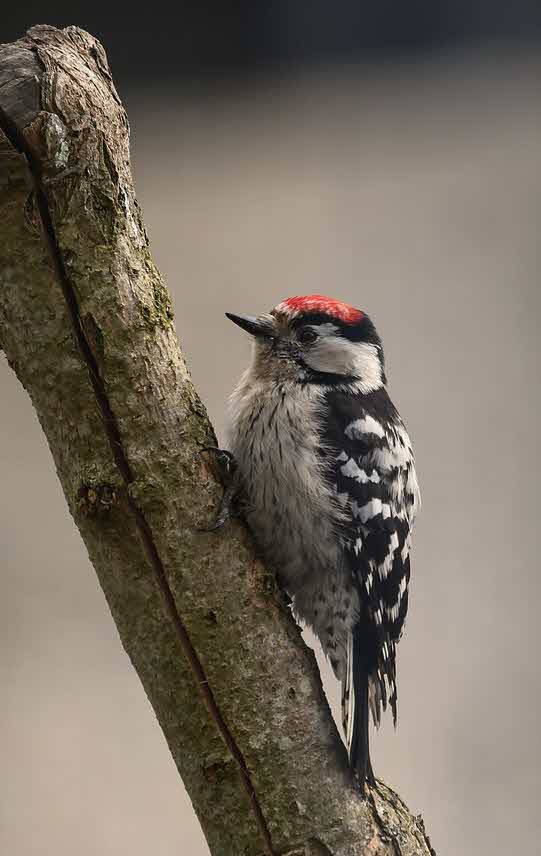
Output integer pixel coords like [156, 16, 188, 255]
[226, 294, 386, 392]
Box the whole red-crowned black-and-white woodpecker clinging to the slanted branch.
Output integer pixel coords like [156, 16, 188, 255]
[216, 294, 420, 793]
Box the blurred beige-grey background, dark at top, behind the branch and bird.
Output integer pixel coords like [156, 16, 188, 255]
[0, 6, 541, 856]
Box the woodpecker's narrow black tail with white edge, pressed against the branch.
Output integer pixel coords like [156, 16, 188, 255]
[342, 625, 376, 793]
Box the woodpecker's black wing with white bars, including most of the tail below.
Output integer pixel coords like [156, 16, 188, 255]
[326, 388, 420, 784]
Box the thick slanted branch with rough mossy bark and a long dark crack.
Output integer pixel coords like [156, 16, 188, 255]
[0, 27, 431, 856]
